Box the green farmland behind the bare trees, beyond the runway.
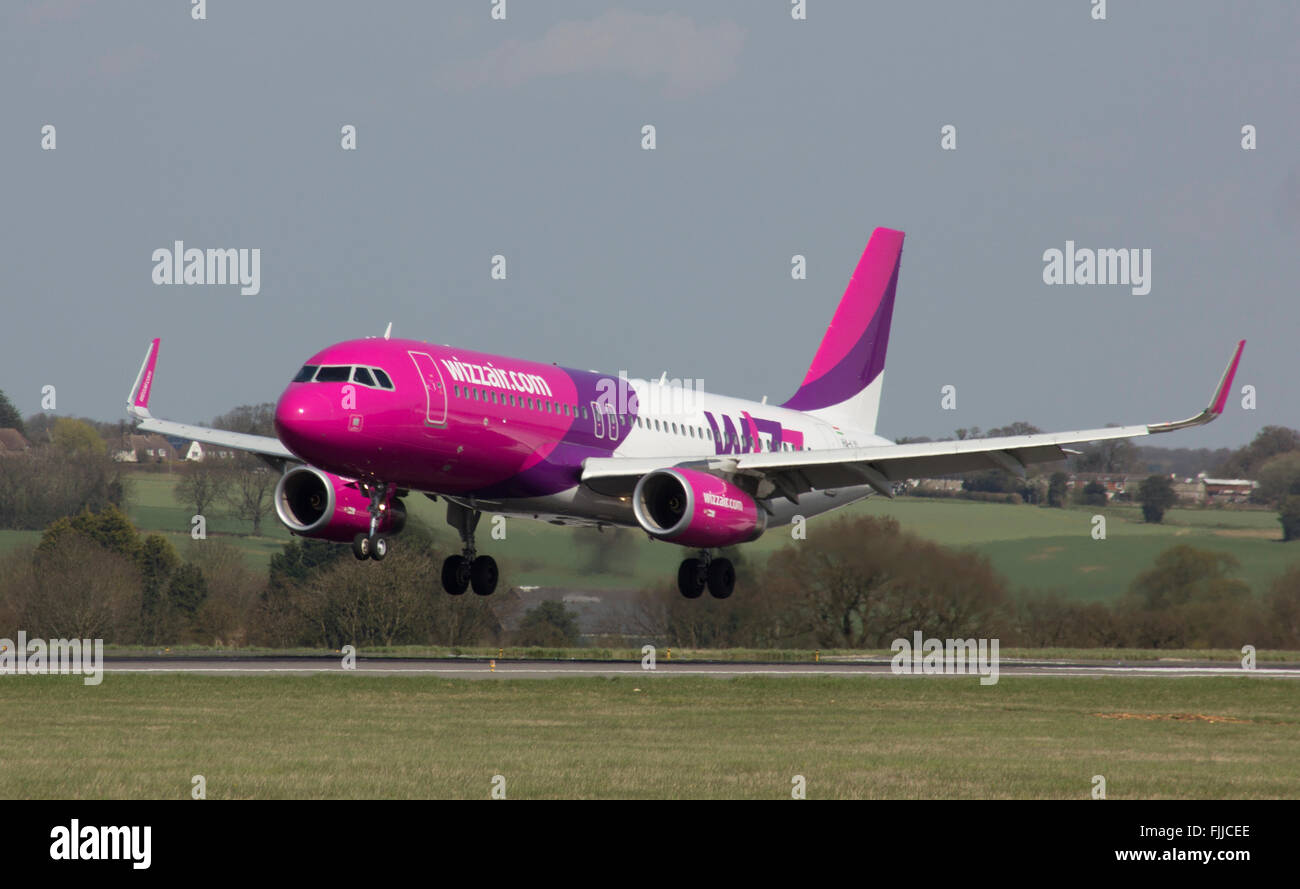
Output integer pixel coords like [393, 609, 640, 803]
[0, 472, 1300, 602]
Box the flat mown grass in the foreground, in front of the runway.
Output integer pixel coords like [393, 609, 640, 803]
[0, 675, 1300, 799]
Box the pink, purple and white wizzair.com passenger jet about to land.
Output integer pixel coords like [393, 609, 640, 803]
[127, 227, 1245, 599]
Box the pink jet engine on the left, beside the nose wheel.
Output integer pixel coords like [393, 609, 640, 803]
[276, 467, 406, 543]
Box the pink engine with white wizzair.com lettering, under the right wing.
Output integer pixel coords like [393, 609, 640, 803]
[632, 469, 767, 547]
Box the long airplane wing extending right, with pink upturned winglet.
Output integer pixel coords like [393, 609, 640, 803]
[582, 339, 1245, 502]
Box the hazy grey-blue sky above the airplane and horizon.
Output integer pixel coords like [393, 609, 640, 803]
[0, 0, 1300, 447]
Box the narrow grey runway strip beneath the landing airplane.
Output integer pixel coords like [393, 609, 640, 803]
[104, 655, 1300, 680]
